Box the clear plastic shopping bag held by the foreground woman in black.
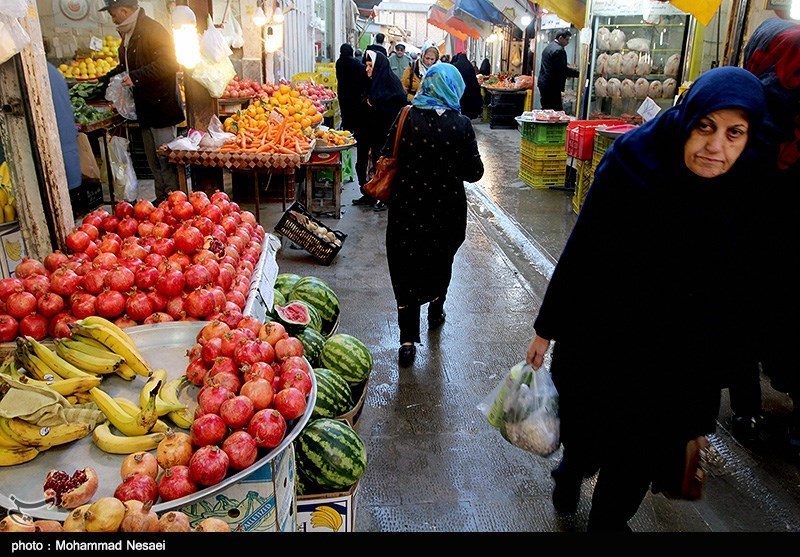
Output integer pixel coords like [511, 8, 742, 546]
[478, 361, 561, 456]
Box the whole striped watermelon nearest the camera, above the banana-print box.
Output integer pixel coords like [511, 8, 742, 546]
[295, 418, 367, 492]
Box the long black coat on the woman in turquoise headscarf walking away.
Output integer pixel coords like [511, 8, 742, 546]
[382, 107, 483, 305]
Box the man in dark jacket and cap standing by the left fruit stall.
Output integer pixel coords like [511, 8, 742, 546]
[99, 0, 185, 204]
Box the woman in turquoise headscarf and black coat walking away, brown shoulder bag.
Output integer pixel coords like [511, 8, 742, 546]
[382, 64, 483, 367]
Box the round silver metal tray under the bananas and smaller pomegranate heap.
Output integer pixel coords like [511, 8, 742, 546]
[0, 321, 317, 521]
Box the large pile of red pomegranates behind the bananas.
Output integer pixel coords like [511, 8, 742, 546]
[0, 191, 265, 342]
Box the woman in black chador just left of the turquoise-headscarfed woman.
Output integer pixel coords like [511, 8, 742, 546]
[353, 50, 408, 211]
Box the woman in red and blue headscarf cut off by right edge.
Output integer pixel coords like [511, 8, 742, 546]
[730, 18, 800, 452]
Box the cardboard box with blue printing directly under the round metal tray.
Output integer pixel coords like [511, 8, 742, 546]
[180, 443, 297, 532]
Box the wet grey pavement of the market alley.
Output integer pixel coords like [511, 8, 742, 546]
[255, 123, 800, 533]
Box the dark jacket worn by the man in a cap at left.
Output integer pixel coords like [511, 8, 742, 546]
[104, 12, 185, 128]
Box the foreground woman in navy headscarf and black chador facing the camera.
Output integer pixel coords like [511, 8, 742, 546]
[526, 66, 764, 531]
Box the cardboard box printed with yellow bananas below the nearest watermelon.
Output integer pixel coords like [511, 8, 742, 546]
[297, 482, 359, 532]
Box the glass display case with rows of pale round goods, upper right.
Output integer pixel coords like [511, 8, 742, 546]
[582, 8, 690, 123]
